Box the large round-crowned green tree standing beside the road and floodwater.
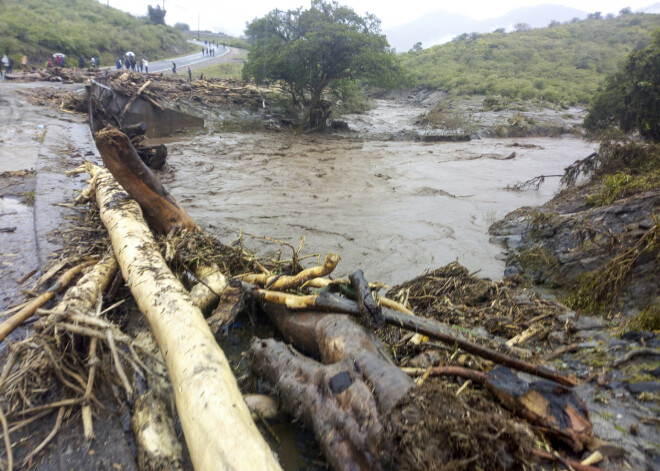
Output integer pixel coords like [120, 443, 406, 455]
[243, 0, 400, 129]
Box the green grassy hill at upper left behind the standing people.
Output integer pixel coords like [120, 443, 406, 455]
[0, 0, 197, 66]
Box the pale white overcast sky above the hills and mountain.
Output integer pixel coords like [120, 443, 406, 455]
[99, 0, 656, 36]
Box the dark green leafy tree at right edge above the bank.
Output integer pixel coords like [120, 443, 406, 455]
[584, 31, 660, 142]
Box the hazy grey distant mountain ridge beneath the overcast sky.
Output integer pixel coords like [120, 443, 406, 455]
[384, 5, 588, 52]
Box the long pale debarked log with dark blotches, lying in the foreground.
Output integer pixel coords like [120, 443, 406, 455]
[87, 164, 281, 471]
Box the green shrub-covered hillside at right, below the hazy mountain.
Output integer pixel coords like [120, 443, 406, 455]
[402, 14, 660, 104]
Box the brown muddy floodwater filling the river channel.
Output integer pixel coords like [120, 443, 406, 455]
[161, 102, 596, 284]
